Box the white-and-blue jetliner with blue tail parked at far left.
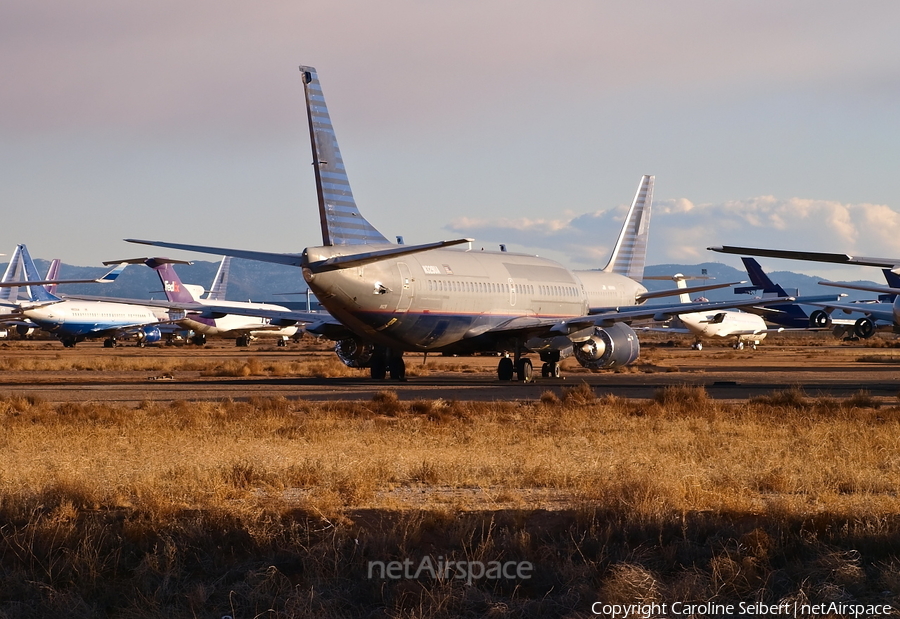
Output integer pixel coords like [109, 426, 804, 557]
[5, 245, 172, 347]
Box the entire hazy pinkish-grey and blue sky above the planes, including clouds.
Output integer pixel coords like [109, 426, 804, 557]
[0, 0, 900, 279]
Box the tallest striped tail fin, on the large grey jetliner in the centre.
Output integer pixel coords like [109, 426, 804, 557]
[300, 67, 389, 245]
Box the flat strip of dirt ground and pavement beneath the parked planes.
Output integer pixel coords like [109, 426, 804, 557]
[0, 334, 900, 406]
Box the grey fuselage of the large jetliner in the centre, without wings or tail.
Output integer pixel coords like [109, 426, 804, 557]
[304, 245, 646, 351]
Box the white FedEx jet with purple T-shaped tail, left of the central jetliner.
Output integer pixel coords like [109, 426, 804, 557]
[103, 256, 302, 346]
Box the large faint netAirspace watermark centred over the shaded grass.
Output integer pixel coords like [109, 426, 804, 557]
[369, 555, 534, 585]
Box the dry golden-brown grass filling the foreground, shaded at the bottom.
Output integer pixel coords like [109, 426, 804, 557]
[0, 390, 900, 617]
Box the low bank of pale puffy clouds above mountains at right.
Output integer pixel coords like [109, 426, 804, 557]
[446, 196, 900, 267]
